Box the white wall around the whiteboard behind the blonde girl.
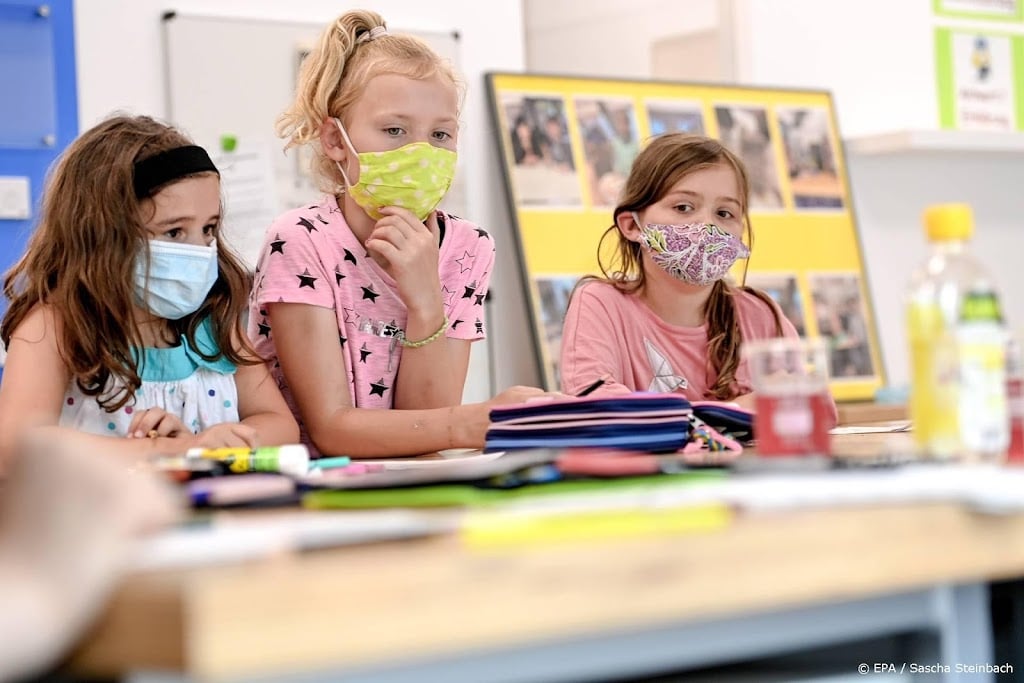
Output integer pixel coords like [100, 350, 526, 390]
[75, 0, 536, 400]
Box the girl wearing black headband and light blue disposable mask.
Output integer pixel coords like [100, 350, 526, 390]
[0, 116, 298, 466]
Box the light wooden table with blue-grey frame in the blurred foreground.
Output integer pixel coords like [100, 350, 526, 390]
[66, 439, 1024, 682]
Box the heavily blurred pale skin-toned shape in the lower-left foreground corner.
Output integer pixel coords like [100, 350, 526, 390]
[0, 429, 179, 681]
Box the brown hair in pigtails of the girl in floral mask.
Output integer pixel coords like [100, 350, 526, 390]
[597, 133, 782, 400]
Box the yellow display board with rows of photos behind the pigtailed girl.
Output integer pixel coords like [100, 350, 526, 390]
[485, 73, 885, 400]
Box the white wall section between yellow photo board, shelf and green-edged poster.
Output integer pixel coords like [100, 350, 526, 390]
[733, 0, 938, 136]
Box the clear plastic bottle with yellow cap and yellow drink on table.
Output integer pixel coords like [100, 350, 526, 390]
[906, 204, 1010, 462]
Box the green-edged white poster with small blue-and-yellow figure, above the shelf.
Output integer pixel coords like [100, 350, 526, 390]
[935, 28, 1024, 132]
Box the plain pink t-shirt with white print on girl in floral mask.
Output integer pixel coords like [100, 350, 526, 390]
[561, 281, 836, 418]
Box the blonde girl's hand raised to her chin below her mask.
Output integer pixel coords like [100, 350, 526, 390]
[366, 207, 442, 312]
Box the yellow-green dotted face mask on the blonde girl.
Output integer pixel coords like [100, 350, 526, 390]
[334, 119, 457, 220]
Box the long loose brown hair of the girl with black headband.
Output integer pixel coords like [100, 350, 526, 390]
[0, 116, 259, 412]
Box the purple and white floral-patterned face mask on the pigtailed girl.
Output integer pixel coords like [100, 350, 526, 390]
[633, 214, 751, 286]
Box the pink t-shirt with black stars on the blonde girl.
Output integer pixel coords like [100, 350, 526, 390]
[249, 196, 495, 454]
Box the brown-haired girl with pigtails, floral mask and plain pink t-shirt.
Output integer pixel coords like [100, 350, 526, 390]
[561, 133, 835, 418]
